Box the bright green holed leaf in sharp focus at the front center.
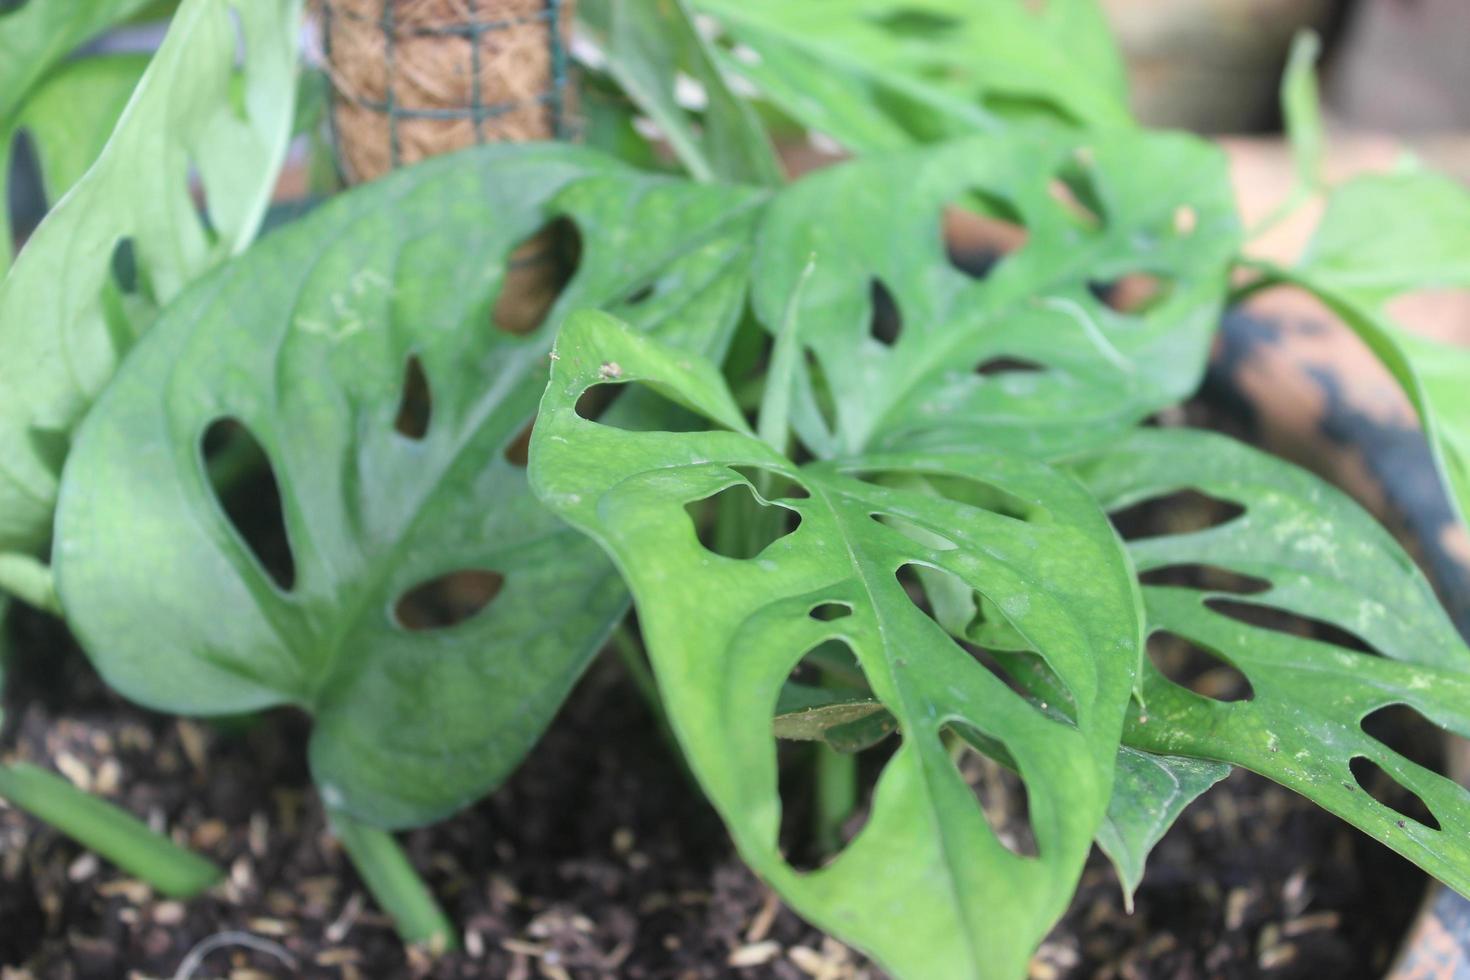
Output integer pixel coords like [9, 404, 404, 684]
[531, 313, 1138, 977]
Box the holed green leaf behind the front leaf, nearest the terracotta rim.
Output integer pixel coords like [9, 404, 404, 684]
[751, 131, 1238, 455]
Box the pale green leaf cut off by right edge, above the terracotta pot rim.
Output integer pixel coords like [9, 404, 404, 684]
[1269, 172, 1470, 531]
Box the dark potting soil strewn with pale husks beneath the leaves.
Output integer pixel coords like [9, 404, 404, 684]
[0, 599, 1424, 980]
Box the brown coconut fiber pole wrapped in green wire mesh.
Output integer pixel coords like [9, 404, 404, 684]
[319, 0, 575, 184]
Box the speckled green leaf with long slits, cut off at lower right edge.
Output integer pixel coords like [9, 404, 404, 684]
[1078, 429, 1470, 892]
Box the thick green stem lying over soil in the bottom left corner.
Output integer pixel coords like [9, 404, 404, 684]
[0, 763, 223, 898]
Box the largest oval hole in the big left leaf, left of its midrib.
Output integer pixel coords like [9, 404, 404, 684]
[200, 419, 295, 592]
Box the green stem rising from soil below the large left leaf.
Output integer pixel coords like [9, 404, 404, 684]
[329, 810, 459, 954]
